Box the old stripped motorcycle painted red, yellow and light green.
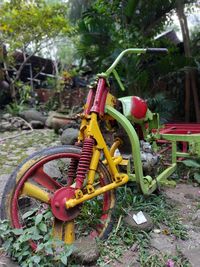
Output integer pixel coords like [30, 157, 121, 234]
[1, 48, 200, 249]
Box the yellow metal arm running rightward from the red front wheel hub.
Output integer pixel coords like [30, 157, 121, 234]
[65, 174, 129, 209]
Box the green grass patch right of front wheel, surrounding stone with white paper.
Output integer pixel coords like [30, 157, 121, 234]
[97, 186, 190, 267]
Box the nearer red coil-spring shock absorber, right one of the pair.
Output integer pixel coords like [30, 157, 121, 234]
[76, 138, 94, 189]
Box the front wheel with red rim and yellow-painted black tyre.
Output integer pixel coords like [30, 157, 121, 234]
[1, 146, 115, 249]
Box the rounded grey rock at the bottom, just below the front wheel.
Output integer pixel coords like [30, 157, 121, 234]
[72, 237, 100, 264]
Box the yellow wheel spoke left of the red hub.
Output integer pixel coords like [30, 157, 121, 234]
[21, 182, 50, 204]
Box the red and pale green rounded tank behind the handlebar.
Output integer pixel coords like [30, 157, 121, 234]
[118, 96, 148, 121]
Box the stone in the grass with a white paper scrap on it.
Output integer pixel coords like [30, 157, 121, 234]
[124, 211, 153, 231]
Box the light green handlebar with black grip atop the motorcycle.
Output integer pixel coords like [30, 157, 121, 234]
[98, 48, 168, 91]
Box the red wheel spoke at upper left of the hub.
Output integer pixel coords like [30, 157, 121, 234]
[31, 166, 61, 192]
